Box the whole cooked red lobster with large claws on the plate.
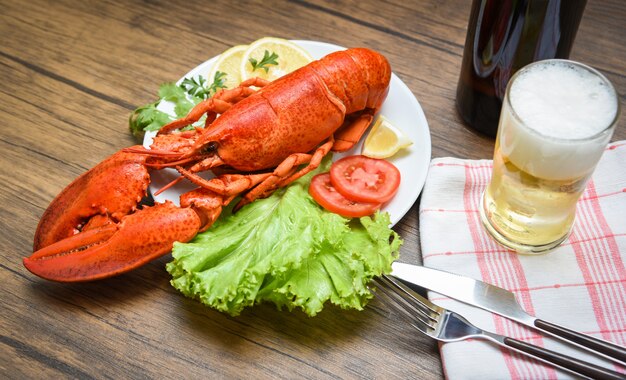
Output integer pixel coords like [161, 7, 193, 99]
[24, 48, 391, 282]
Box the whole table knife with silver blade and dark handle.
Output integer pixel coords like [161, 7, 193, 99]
[391, 262, 626, 365]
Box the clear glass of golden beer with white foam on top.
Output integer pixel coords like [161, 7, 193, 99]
[480, 59, 619, 254]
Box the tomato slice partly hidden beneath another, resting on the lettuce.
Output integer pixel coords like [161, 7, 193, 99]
[309, 173, 382, 218]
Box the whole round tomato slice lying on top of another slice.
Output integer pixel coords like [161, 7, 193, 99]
[330, 156, 400, 203]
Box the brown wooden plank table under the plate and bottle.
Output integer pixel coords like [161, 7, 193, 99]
[0, 0, 626, 379]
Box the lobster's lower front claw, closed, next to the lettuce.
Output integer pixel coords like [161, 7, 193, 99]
[24, 202, 201, 282]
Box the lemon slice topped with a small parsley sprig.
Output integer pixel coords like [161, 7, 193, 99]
[240, 37, 313, 81]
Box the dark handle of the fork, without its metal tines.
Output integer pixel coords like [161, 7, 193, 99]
[504, 337, 626, 380]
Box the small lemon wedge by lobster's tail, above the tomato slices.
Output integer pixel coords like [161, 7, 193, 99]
[361, 115, 413, 158]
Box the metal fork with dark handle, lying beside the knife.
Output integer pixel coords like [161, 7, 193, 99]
[373, 275, 626, 380]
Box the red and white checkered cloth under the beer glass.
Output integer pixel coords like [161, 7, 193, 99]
[420, 141, 626, 379]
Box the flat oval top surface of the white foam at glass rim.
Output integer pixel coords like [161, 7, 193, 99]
[509, 60, 617, 139]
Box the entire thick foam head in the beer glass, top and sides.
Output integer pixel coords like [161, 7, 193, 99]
[499, 60, 618, 180]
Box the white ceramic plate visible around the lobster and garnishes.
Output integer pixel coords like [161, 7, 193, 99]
[144, 41, 431, 225]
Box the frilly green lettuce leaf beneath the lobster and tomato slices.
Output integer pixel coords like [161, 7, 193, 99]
[167, 158, 402, 316]
